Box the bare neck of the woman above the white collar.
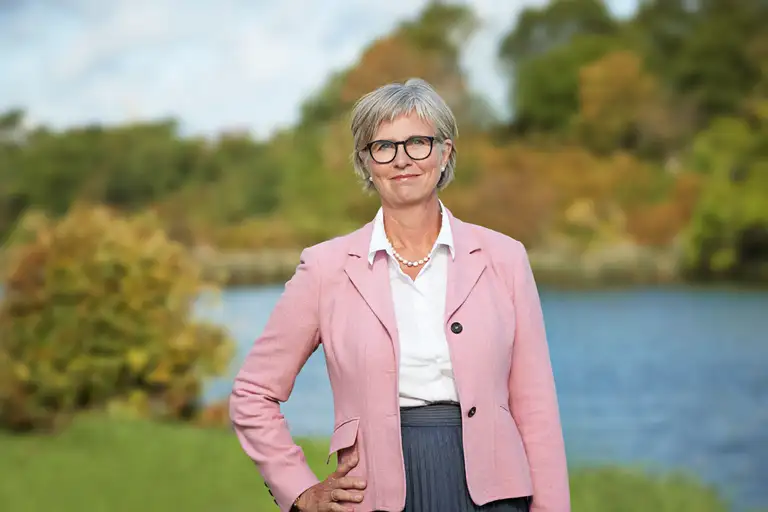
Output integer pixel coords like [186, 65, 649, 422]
[382, 194, 441, 253]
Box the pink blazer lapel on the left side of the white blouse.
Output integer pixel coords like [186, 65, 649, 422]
[344, 224, 400, 360]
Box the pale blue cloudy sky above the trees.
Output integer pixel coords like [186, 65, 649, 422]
[0, 0, 634, 138]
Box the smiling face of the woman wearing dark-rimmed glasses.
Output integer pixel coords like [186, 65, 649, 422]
[366, 114, 452, 207]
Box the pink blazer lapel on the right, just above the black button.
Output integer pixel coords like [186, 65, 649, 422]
[445, 211, 486, 323]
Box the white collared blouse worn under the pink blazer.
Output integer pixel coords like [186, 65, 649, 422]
[368, 204, 459, 407]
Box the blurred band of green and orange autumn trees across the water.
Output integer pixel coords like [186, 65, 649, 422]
[0, 0, 768, 278]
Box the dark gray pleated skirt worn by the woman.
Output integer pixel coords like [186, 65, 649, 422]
[400, 404, 529, 512]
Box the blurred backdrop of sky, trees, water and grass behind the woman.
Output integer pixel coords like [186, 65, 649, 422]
[0, 0, 768, 512]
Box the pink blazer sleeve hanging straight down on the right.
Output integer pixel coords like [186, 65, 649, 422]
[509, 242, 570, 512]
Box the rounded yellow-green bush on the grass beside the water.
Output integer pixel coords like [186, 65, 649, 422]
[0, 206, 232, 429]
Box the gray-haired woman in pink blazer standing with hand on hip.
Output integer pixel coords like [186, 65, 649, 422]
[230, 79, 570, 512]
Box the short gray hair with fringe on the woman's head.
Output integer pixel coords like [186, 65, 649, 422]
[351, 78, 458, 190]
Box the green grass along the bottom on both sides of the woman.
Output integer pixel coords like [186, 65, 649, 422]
[0, 416, 740, 512]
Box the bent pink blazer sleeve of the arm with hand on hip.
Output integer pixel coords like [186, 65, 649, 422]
[229, 249, 320, 512]
